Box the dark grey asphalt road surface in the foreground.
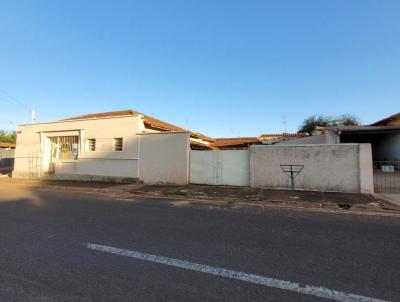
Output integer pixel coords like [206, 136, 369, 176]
[0, 186, 400, 302]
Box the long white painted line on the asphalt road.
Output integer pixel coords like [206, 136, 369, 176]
[87, 243, 388, 302]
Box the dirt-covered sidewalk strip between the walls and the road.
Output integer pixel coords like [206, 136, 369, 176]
[0, 177, 400, 214]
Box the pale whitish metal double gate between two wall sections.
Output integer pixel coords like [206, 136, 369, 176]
[190, 150, 250, 186]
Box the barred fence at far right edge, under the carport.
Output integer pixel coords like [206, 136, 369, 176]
[374, 161, 400, 193]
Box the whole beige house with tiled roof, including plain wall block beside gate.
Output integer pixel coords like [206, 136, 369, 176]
[13, 110, 213, 184]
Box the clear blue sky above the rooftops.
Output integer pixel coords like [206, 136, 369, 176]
[0, 0, 400, 137]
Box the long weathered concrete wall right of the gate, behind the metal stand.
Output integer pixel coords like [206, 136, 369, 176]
[250, 144, 374, 193]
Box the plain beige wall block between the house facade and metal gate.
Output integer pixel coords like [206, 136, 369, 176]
[138, 132, 190, 184]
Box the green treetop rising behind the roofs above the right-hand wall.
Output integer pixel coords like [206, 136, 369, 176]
[298, 114, 360, 134]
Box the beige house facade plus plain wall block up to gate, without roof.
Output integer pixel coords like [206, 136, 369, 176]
[13, 116, 190, 184]
